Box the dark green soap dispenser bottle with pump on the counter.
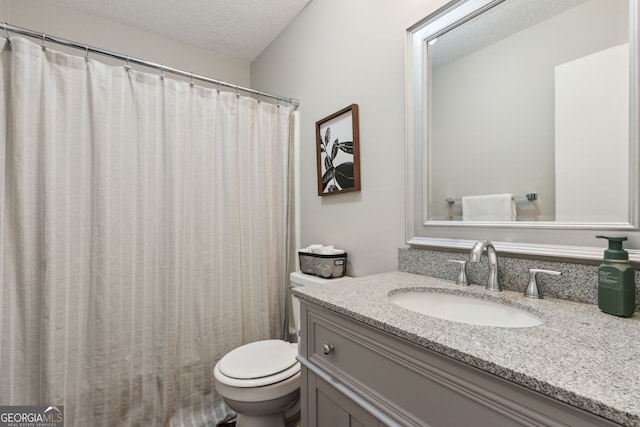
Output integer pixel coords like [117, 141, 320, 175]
[596, 236, 636, 317]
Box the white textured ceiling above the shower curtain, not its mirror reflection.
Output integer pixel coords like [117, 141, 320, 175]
[58, 0, 310, 62]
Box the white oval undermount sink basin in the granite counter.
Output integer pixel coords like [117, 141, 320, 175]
[389, 291, 544, 328]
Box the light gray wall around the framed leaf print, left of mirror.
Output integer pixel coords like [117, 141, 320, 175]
[251, 0, 446, 276]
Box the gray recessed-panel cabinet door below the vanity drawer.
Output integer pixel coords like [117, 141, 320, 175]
[307, 372, 384, 427]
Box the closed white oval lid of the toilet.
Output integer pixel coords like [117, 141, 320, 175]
[218, 340, 298, 380]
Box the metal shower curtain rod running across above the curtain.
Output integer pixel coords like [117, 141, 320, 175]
[0, 22, 300, 108]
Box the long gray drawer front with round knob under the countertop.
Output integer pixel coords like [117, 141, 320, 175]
[302, 306, 615, 427]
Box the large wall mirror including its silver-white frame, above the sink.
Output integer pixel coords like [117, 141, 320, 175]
[407, 0, 640, 258]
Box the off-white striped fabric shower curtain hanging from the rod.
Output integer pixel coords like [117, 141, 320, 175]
[0, 37, 293, 426]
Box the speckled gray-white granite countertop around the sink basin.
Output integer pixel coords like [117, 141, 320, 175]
[293, 272, 640, 426]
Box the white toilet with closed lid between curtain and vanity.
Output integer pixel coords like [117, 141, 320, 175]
[213, 272, 340, 427]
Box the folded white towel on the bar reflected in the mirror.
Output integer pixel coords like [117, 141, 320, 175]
[462, 194, 516, 221]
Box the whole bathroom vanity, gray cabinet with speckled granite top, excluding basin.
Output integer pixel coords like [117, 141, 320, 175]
[294, 272, 640, 426]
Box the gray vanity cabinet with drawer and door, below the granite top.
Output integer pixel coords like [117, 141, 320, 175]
[299, 301, 617, 427]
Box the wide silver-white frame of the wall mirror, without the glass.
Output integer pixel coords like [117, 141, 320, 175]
[405, 0, 640, 262]
